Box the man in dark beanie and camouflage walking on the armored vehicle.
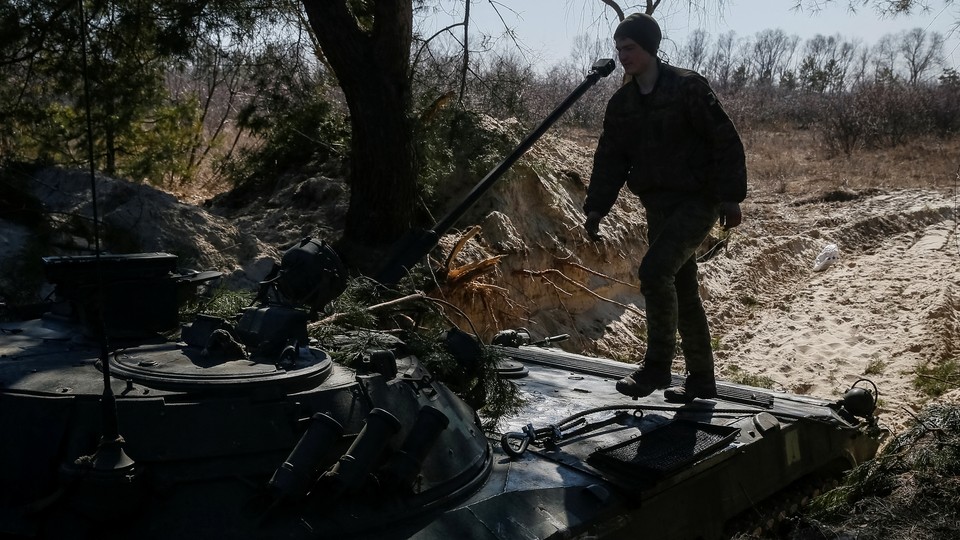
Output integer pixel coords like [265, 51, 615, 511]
[583, 13, 747, 403]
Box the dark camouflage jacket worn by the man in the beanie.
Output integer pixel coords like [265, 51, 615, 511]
[583, 60, 747, 215]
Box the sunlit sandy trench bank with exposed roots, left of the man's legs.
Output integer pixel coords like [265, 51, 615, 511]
[432, 133, 646, 361]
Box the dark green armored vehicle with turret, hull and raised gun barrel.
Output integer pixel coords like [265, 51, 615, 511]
[0, 61, 883, 540]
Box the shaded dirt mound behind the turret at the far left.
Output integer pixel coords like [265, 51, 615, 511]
[0, 168, 276, 301]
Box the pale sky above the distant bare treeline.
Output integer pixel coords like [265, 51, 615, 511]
[432, 0, 960, 66]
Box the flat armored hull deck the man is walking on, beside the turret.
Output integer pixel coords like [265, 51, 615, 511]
[446, 347, 884, 539]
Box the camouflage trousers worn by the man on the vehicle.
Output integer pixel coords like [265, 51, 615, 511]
[639, 199, 719, 375]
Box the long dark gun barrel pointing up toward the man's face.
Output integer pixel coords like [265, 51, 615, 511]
[377, 58, 614, 285]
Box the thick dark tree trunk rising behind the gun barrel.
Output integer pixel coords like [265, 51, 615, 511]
[303, 0, 417, 249]
